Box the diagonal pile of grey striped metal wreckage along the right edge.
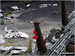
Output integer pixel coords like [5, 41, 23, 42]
[45, 11, 75, 56]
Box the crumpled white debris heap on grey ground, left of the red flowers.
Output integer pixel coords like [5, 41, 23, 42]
[4, 27, 29, 38]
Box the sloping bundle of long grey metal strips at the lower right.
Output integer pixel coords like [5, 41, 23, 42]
[45, 13, 75, 56]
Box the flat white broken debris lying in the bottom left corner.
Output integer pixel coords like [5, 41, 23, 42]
[0, 46, 28, 56]
